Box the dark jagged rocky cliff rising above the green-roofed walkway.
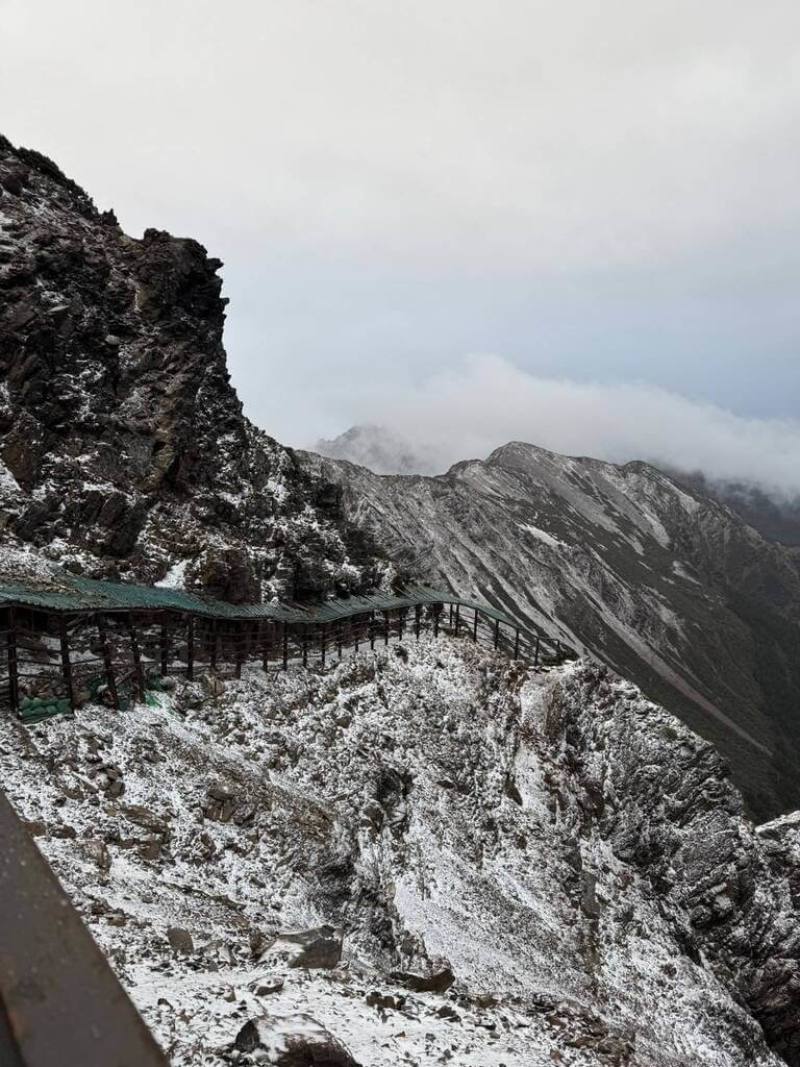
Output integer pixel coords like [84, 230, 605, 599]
[0, 138, 386, 600]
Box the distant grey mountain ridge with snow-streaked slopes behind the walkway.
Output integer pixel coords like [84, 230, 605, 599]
[305, 444, 800, 817]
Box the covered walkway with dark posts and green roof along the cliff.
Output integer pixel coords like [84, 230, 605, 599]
[0, 575, 572, 721]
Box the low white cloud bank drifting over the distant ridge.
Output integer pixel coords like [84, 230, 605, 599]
[328, 355, 800, 496]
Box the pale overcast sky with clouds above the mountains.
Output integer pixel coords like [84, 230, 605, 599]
[0, 0, 800, 492]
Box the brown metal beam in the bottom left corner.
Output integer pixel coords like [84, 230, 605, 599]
[0, 792, 167, 1067]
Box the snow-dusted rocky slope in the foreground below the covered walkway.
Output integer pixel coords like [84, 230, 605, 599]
[0, 639, 800, 1067]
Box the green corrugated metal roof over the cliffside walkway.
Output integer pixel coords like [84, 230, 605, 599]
[0, 572, 518, 626]
